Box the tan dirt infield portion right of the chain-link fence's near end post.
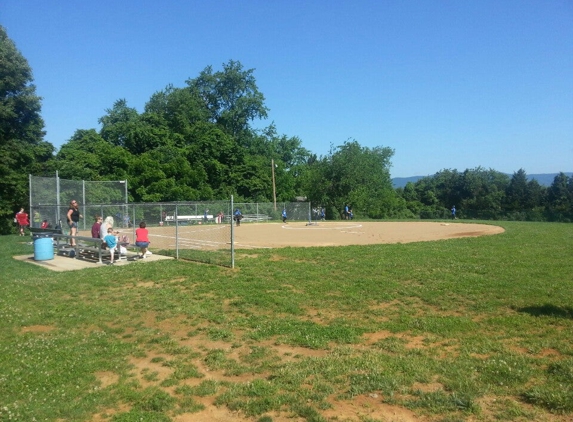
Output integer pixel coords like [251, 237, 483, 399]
[230, 221, 504, 249]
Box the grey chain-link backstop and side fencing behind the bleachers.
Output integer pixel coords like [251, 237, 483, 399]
[30, 176, 314, 267]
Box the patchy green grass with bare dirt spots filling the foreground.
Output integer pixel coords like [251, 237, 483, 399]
[0, 222, 573, 422]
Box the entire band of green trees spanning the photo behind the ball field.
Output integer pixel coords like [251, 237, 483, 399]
[0, 26, 573, 234]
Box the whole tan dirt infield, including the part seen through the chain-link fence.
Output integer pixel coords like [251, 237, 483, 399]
[81, 221, 504, 251]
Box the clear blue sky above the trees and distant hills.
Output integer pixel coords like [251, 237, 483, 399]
[0, 0, 573, 177]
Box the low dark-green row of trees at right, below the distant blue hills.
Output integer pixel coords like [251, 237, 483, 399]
[397, 167, 573, 222]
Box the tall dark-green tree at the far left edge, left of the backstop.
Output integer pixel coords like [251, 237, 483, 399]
[0, 26, 54, 234]
